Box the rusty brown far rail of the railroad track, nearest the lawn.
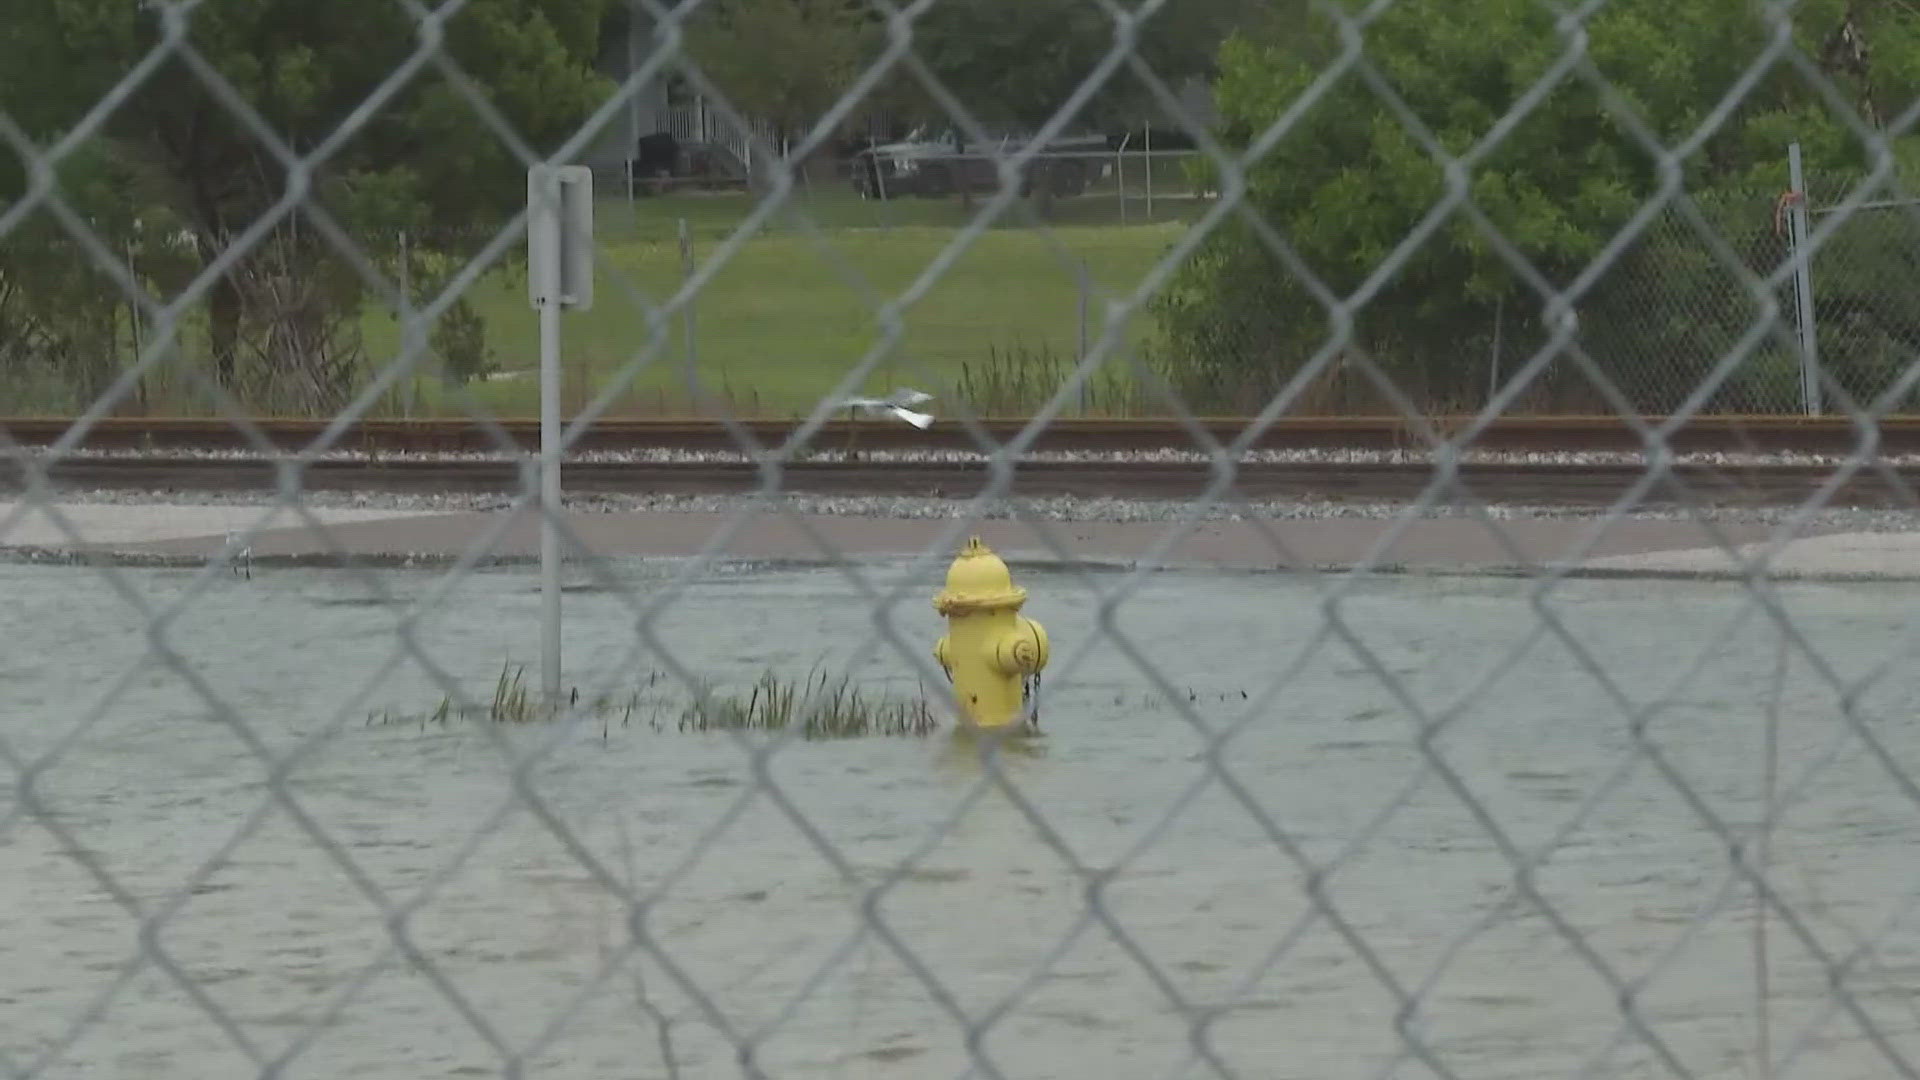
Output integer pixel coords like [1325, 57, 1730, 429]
[0, 417, 1920, 454]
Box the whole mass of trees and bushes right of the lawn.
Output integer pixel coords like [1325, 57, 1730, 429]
[1158, 0, 1920, 411]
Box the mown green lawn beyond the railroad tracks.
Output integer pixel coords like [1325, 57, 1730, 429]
[367, 194, 1190, 417]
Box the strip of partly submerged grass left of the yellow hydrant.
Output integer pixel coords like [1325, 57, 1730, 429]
[367, 663, 941, 740]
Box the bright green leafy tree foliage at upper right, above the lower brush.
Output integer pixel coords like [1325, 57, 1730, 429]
[1160, 0, 1920, 407]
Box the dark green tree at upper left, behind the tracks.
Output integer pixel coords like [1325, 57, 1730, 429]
[0, 0, 612, 398]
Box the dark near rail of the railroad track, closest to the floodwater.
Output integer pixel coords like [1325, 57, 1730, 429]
[0, 455, 1920, 507]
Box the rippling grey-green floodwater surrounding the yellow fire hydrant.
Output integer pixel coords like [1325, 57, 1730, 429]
[0, 563, 1920, 1080]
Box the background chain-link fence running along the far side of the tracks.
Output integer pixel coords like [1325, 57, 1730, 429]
[15, 139, 1910, 417]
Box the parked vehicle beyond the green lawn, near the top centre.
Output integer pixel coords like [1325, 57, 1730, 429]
[852, 127, 1112, 198]
